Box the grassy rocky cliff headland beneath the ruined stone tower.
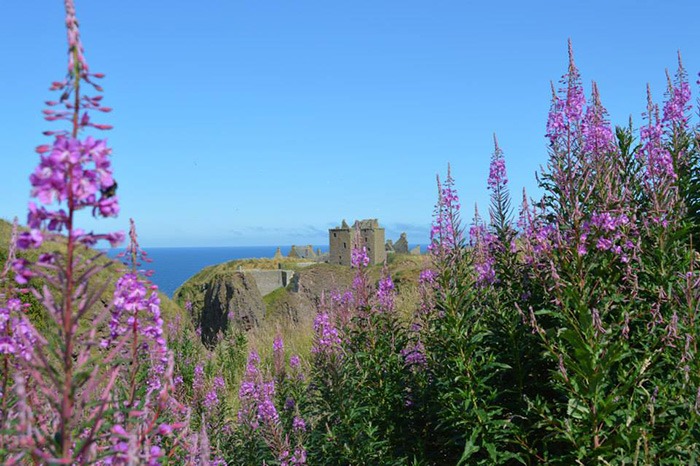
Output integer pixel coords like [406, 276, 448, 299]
[173, 251, 429, 344]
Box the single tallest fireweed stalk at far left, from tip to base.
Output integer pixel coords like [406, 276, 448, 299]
[14, 0, 123, 463]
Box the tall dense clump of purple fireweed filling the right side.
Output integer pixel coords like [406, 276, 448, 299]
[416, 41, 700, 465]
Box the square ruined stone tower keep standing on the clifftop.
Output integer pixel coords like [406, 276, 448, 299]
[328, 218, 386, 266]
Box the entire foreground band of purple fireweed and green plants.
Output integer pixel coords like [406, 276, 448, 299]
[0, 0, 700, 465]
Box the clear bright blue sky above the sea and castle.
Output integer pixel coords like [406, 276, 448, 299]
[0, 0, 700, 246]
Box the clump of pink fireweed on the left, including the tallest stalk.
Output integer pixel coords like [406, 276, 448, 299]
[0, 0, 213, 464]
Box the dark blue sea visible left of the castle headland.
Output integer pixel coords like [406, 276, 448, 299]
[108, 245, 328, 297]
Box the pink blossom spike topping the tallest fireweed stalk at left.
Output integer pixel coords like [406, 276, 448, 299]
[18, 0, 124, 255]
